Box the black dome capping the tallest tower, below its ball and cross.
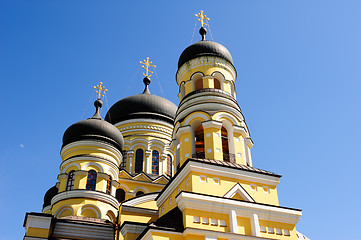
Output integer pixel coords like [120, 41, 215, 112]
[178, 41, 233, 69]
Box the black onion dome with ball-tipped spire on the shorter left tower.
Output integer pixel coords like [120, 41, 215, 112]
[63, 100, 124, 151]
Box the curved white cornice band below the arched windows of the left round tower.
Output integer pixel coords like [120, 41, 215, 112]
[51, 190, 119, 207]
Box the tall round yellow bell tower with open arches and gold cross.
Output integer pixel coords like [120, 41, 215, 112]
[173, 11, 253, 168]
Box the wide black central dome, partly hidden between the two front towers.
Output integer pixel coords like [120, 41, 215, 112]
[105, 92, 177, 125]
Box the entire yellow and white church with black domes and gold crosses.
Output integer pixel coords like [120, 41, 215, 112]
[24, 11, 308, 240]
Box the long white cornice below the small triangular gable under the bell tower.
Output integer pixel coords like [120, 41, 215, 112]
[176, 192, 302, 224]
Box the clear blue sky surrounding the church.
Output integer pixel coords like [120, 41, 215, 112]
[0, 0, 361, 239]
